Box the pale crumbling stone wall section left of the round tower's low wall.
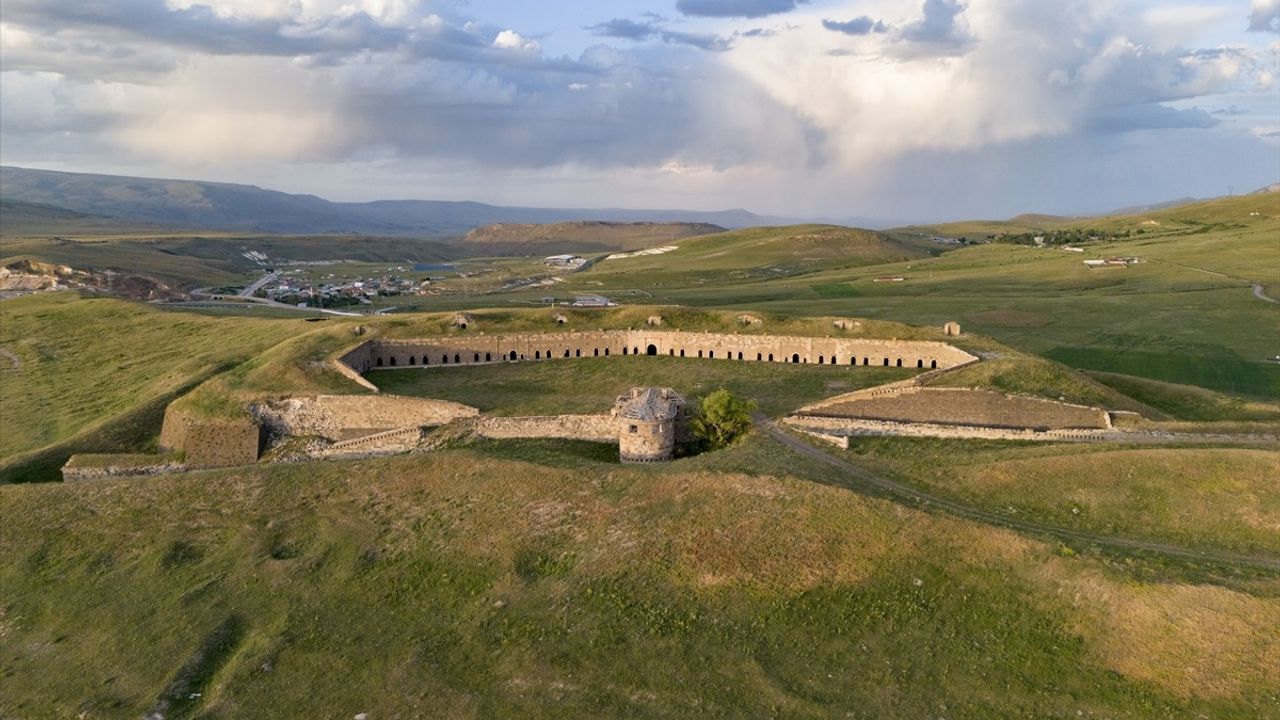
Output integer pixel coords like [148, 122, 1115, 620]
[252, 395, 480, 441]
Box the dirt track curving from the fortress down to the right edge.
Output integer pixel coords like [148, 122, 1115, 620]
[755, 415, 1280, 570]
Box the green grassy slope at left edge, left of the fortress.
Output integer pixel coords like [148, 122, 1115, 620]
[0, 293, 302, 469]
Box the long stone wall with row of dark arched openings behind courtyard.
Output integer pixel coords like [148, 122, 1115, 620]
[339, 327, 978, 371]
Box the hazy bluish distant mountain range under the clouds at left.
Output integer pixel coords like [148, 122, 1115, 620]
[0, 165, 797, 237]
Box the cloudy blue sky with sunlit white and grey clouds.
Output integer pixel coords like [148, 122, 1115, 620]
[0, 0, 1280, 220]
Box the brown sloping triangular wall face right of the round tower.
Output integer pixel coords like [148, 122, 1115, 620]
[804, 388, 1111, 430]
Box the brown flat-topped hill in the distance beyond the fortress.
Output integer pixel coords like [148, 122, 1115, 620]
[460, 222, 724, 255]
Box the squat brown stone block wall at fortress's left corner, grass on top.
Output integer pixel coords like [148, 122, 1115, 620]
[160, 405, 262, 468]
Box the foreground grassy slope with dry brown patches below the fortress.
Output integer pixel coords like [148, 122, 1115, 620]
[0, 445, 1280, 720]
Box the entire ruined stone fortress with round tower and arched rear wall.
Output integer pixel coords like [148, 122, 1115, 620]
[64, 315, 1162, 479]
